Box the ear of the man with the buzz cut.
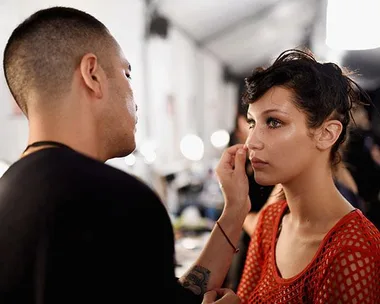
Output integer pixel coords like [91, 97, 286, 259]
[80, 53, 104, 98]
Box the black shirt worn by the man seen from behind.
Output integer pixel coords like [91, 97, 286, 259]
[0, 148, 201, 304]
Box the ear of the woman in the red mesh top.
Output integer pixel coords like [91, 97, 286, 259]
[315, 120, 343, 150]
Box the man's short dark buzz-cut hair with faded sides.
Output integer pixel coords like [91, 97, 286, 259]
[3, 7, 114, 115]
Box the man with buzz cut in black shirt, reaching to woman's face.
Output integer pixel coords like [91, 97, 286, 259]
[0, 7, 250, 304]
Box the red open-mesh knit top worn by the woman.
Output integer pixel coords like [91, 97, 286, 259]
[238, 202, 380, 304]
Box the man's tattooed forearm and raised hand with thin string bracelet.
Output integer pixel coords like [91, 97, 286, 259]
[180, 144, 251, 295]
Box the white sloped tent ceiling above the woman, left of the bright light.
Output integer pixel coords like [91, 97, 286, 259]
[158, 0, 321, 74]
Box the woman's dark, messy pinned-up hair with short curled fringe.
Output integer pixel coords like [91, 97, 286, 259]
[242, 49, 370, 165]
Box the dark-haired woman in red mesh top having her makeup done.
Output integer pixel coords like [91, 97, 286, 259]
[229, 50, 380, 303]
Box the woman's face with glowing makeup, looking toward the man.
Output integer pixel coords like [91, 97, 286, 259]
[246, 87, 318, 185]
